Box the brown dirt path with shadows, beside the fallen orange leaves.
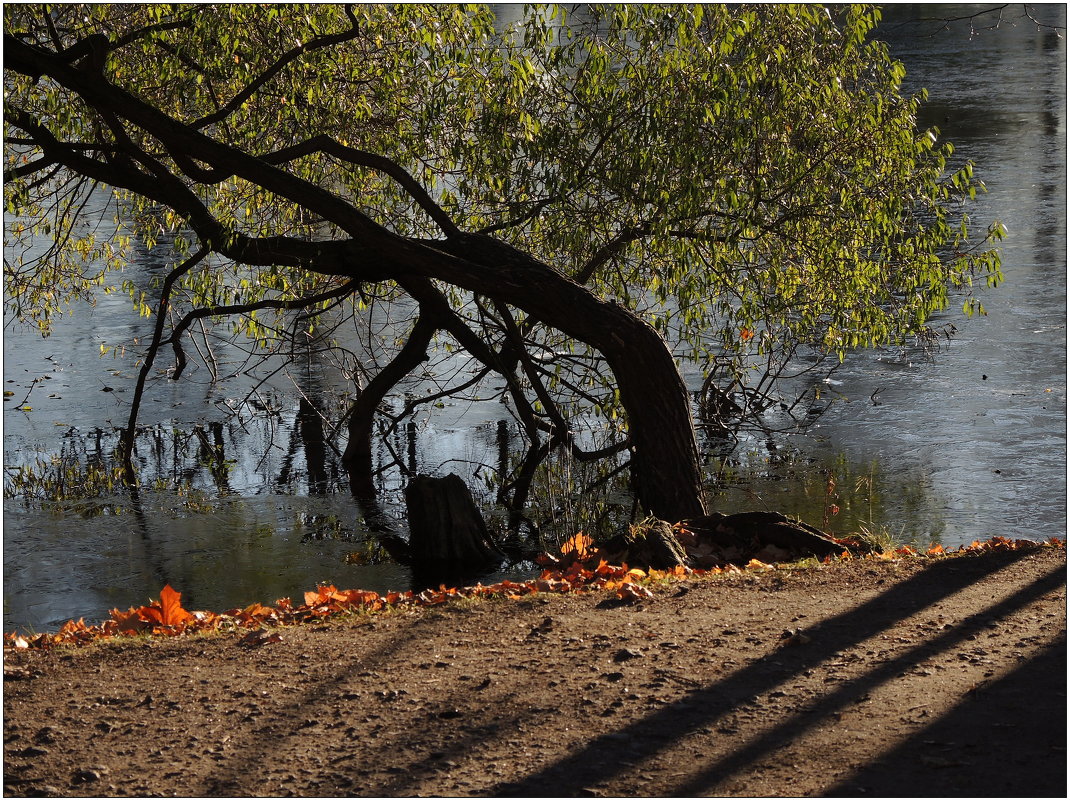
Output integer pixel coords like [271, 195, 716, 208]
[3, 548, 1067, 797]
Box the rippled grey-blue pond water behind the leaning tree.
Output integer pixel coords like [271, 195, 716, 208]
[4, 5, 1067, 630]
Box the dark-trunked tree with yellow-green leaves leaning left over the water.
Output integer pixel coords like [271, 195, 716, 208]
[3, 4, 999, 528]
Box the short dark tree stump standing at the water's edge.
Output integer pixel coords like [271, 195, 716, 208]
[404, 473, 505, 570]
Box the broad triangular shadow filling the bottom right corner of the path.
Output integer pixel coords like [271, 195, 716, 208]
[825, 637, 1067, 798]
